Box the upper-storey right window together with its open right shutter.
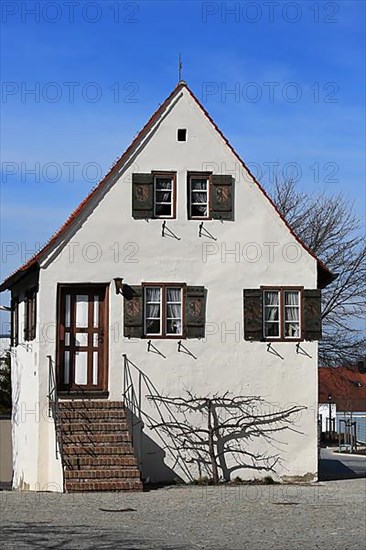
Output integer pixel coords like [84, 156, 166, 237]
[187, 172, 234, 221]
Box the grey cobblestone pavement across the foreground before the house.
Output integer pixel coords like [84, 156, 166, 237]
[0, 479, 366, 550]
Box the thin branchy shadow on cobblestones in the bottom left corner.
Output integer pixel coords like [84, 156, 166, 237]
[1, 522, 191, 550]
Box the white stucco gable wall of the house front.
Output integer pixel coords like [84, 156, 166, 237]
[10, 89, 317, 492]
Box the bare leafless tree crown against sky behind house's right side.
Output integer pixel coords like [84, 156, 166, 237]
[272, 181, 366, 366]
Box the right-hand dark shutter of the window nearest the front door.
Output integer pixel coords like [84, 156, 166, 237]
[184, 286, 206, 338]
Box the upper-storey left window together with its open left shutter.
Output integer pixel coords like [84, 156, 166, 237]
[132, 171, 176, 219]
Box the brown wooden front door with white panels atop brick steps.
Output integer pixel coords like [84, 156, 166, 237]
[57, 285, 108, 393]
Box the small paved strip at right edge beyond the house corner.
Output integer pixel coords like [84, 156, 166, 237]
[319, 448, 366, 480]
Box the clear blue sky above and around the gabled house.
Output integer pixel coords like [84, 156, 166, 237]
[1, 0, 365, 310]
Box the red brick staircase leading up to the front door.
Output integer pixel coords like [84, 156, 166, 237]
[59, 400, 143, 492]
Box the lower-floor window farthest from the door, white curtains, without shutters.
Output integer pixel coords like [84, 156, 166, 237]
[263, 288, 301, 340]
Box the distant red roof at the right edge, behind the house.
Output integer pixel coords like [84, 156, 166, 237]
[318, 367, 366, 411]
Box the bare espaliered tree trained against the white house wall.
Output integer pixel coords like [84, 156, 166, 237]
[147, 392, 306, 483]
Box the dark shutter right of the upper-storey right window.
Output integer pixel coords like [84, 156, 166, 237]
[210, 174, 234, 221]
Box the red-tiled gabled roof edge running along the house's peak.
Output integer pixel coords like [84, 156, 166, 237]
[0, 81, 334, 291]
